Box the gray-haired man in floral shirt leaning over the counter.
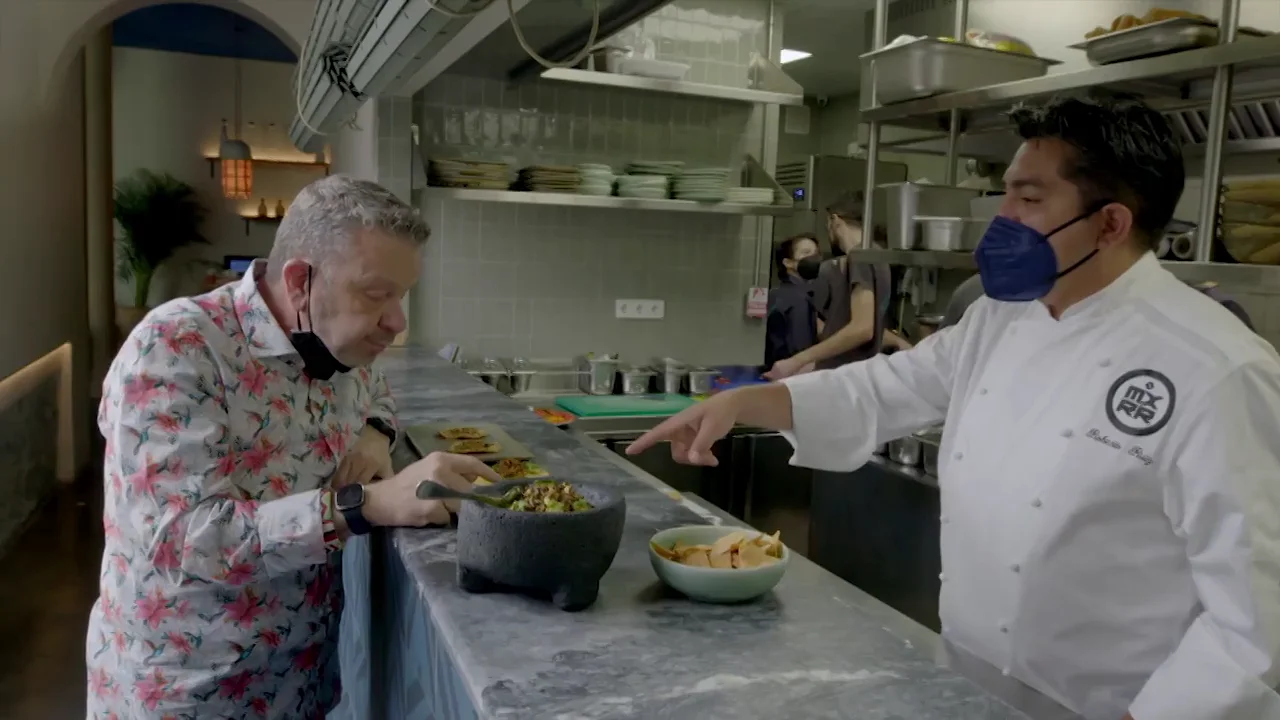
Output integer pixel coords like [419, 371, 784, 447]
[87, 176, 498, 720]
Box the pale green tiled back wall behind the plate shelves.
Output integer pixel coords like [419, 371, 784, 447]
[404, 0, 768, 363]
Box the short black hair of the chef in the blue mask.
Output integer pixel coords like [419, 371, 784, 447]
[1009, 96, 1187, 247]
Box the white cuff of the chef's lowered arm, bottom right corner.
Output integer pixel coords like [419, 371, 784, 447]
[1129, 618, 1280, 720]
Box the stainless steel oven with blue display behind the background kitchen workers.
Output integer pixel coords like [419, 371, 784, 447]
[773, 155, 906, 249]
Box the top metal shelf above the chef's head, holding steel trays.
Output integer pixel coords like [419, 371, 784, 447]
[860, 35, 1280, 131]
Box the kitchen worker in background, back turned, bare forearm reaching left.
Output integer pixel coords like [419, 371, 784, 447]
[765, 192, 910, 380]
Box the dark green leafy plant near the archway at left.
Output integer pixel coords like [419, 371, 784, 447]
[115, 169, 209, 307]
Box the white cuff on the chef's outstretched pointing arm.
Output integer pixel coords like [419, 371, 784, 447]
[782, 370, 876, 473]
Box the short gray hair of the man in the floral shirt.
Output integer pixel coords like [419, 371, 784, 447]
[268, 176, 431, 277]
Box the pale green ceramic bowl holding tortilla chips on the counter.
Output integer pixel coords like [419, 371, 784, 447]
[649, 525, 791, 602]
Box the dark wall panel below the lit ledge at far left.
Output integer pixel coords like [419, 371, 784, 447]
[0, 378, 58, 550]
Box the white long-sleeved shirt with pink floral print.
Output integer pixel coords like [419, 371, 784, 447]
[86, 263, 394, 720]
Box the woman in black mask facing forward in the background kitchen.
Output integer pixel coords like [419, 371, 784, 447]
[764, 233, 822, 368]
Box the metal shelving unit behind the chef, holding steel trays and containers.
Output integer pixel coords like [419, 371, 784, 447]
[859, 0, 1280, 278]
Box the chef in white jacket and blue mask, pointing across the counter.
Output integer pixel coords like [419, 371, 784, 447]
[630, 94, 1280, 720]
